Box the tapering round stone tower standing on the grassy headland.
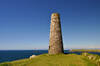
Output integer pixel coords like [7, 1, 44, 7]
[48, 13, 64, 54]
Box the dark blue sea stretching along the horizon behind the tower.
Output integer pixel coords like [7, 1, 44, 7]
[0, 50, 100, 63]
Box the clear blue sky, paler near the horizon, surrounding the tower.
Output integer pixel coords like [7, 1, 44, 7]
[0, 0, 100, 50]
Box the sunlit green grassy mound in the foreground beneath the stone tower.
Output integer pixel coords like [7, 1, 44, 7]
[0, 54, 96, 66]
